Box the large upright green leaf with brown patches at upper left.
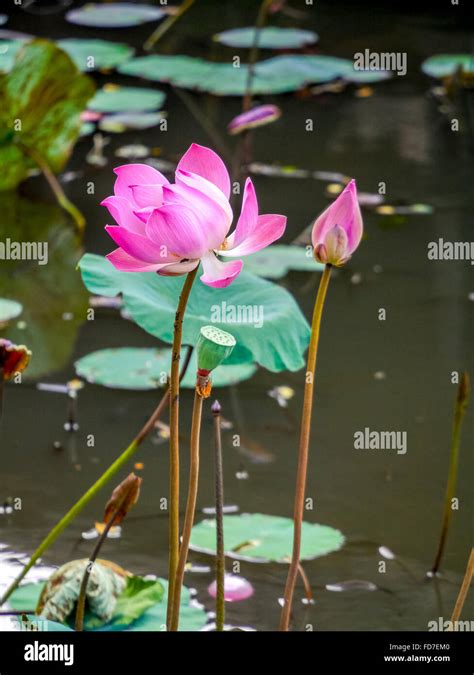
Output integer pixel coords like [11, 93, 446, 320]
[0, 40, 95, 190]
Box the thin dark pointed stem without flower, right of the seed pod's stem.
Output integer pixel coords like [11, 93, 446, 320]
[212, 401, 225, 631]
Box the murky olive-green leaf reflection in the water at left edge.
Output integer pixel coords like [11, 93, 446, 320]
[0, 195, 88, 379]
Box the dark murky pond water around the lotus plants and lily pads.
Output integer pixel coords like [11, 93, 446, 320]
[0, 0, 474, 630]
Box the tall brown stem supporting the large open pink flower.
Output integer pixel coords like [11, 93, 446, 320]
[166, 267, 198, 628]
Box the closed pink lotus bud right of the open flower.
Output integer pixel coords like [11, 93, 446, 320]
[311, 180, 363, 267]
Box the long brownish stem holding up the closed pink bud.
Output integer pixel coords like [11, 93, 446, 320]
[280, 265, 332, 631]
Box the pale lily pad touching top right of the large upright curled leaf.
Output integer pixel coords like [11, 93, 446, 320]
[56, 38, 135, 72]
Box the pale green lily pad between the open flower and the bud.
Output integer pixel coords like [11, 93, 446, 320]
[237, 244, 324, 279]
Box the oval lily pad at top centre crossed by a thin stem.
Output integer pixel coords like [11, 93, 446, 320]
[214, 26, 319, 49]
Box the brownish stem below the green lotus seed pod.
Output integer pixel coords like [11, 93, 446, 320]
[168, 391, 203, 631]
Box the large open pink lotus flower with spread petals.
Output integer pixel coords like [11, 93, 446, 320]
[102, 143, 286, 288]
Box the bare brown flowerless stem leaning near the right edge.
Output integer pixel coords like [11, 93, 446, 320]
[431, 373, 470, 575]
